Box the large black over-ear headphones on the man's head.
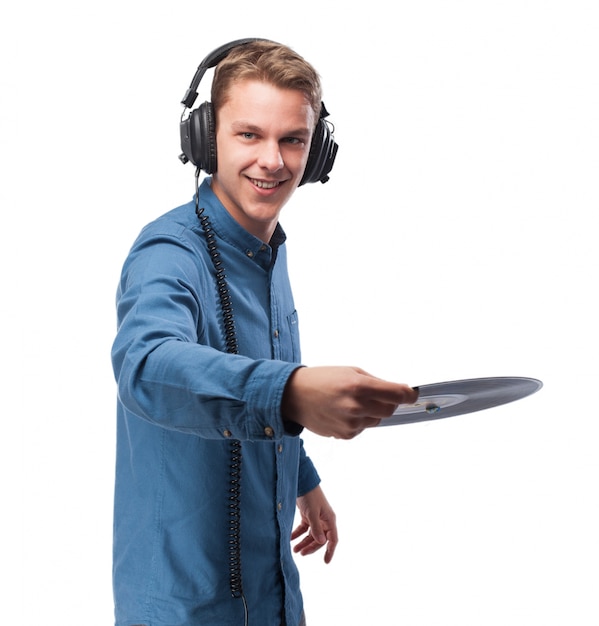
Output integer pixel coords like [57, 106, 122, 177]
[179, 38, 339, 185]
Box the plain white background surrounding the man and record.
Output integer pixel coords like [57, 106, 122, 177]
[0, 0, 599, 626]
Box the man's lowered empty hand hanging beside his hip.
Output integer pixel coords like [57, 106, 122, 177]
[291, 486, 338, 563]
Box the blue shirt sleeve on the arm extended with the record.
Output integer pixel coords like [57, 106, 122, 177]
[112, 224, 299, 440]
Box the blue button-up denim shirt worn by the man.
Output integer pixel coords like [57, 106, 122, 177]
[112, 179, 319, 626]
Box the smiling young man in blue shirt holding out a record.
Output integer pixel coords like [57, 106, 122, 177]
[112, 40, 417, 626]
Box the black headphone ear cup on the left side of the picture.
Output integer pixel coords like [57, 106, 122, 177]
[181, 102, 216, 174]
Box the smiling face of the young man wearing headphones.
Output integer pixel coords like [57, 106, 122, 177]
[212, 80, 314, 242]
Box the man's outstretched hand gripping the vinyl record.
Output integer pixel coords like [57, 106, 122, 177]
[282, 367, 418, 439]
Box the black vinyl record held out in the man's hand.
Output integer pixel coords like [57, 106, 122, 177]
[379, 376, 543, 426]
